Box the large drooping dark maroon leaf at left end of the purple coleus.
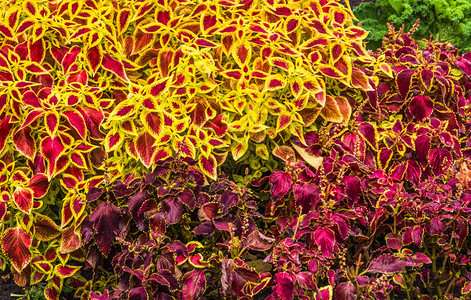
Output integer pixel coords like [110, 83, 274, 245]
[90, 201, 121, 256]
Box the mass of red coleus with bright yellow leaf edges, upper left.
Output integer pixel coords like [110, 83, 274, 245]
[0, 0, 374, 299]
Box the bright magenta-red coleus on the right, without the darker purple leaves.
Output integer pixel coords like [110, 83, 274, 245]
[276, 22, 471, 299]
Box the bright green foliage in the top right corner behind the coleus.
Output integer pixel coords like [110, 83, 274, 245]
[353, 0, 471, 51]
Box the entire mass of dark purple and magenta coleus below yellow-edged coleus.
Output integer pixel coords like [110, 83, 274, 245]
[82, 28, 471, 299]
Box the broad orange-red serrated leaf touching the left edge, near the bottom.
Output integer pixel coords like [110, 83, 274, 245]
[0, 227, 32, 273]
